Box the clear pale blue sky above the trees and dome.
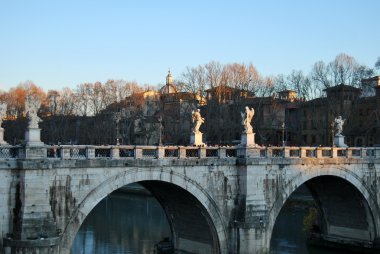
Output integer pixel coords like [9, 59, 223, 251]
[0, 0, 380, 91]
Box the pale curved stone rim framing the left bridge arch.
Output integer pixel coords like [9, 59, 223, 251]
[61, 168, 229, 253]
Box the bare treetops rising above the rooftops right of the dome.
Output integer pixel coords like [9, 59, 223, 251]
[181, 54, 380, 100]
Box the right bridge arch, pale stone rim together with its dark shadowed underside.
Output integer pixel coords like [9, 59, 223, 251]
[268, 167, 380, 249]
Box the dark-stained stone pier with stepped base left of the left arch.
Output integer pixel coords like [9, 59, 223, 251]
[3, 164, 60, 254]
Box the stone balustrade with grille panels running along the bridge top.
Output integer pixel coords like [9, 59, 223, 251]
[0, 145, 380, 160]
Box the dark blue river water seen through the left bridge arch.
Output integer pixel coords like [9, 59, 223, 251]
[71, 185, 171, 254]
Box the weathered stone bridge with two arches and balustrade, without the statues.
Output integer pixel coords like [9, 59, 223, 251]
[0, 145, 380, 253]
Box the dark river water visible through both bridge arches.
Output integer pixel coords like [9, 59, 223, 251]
[71, 185, 350, 254]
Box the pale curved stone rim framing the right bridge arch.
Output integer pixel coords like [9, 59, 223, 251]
[268, 167, 380, 244]
